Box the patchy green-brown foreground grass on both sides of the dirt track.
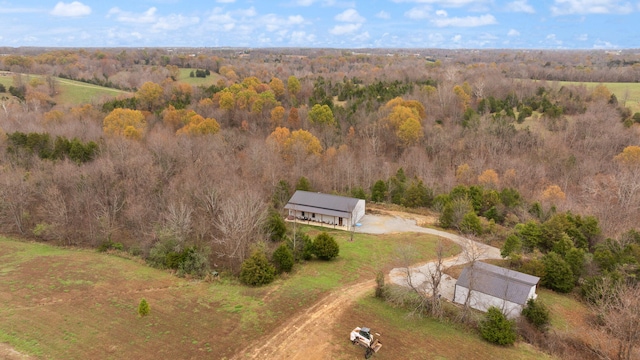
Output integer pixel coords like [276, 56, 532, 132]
[0, 226, 556, 359]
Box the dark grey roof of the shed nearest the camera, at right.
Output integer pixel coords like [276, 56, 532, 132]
[456, 261, 540, 305]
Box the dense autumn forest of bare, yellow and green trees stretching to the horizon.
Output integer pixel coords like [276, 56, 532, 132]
[0, 48, 640, 271]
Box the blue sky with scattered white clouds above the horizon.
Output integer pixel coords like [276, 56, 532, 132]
[0, 0, 640, 49]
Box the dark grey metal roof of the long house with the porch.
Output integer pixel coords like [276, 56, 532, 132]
[284, 190, 360, 217]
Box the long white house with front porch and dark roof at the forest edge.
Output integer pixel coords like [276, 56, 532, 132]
[284, 190, 365, 230]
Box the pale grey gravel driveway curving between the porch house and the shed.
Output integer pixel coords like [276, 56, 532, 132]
[356, 214, 501, 301]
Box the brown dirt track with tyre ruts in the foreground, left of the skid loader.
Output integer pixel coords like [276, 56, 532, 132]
[232, 280, 375, 360]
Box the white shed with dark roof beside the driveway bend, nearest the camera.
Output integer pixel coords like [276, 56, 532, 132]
[453, 261, 540, 319]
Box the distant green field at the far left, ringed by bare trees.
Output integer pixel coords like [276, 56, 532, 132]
[0, 75, 129, 105]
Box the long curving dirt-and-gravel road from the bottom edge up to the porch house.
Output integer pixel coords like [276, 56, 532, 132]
[232, 215, 500, 360]
